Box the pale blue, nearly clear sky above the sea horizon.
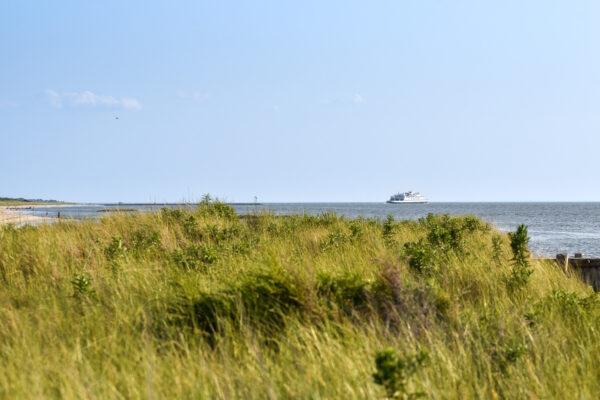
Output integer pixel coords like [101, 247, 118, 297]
[0, 0, 600, 202]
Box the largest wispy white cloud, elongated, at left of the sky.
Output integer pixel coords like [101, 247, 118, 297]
[46, 89, 142, 110]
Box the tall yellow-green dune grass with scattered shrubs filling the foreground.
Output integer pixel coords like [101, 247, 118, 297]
[0, 203, 600, 399]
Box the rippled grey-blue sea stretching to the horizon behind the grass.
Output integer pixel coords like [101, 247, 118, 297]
[21, 203, 600, 257]
